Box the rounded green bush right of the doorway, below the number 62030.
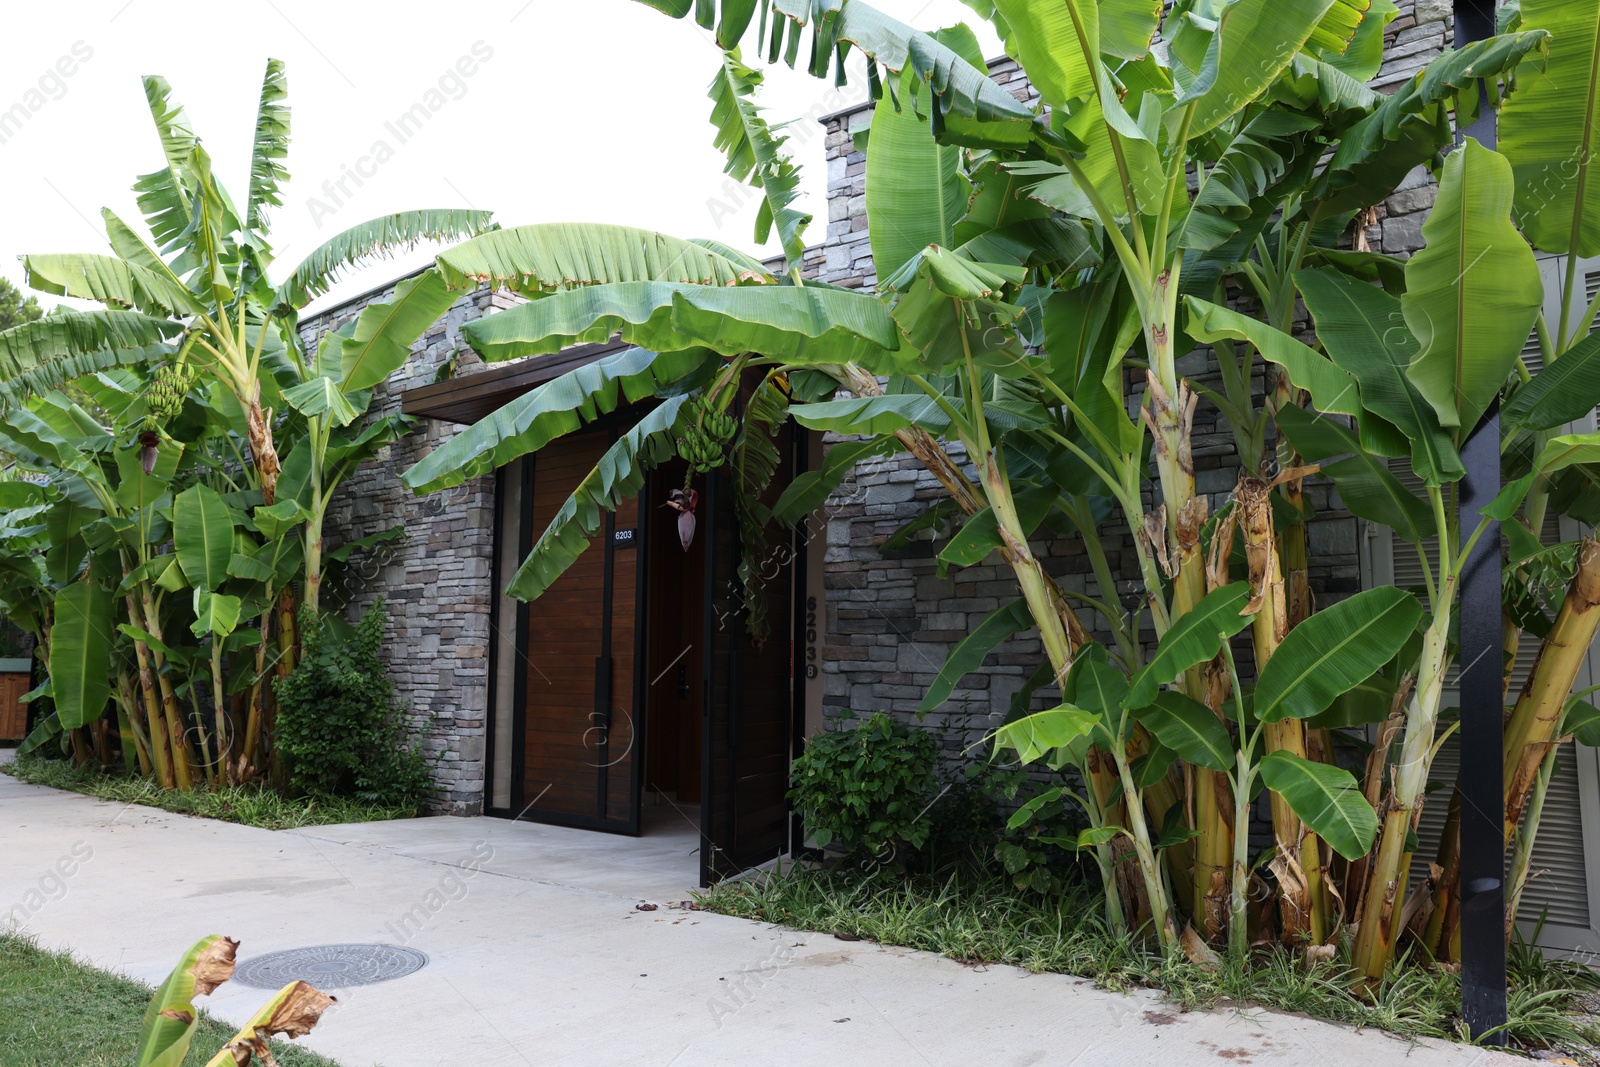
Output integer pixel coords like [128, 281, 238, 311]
[789, 712, 939, 865]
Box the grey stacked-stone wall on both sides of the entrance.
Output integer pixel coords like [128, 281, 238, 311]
[306, 0, 1451, 814]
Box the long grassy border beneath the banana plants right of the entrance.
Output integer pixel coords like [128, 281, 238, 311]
[702, 865, 1600, 1056]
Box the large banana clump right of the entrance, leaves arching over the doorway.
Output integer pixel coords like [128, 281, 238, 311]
[393, 0, 1600, 976]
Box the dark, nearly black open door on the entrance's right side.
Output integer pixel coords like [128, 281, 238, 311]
[701, 432, 800, 885]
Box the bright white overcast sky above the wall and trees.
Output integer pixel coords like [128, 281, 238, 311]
[0, 0, 1000, 316]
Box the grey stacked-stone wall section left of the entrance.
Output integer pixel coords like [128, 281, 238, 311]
[292, 285, 517, 814]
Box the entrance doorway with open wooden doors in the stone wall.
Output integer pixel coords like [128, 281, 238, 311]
[490, 413, 805, 885]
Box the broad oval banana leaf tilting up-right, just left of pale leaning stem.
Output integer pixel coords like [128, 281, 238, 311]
[1254, 585, 1422, 723]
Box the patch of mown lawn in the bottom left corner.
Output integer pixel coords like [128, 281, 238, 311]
[0, 934, 338, 1067]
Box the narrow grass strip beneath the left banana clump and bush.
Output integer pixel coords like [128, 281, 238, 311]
[0, 757, 416, 830]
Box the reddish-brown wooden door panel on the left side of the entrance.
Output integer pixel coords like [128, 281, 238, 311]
[515, 430, 643, 833]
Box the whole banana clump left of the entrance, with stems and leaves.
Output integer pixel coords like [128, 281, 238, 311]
[0, 59, 493, 785]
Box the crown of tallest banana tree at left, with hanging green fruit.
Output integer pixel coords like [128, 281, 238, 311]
[0, 59, 493, 607]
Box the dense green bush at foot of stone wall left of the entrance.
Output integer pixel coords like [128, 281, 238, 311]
[277, 601, 434, 808]
